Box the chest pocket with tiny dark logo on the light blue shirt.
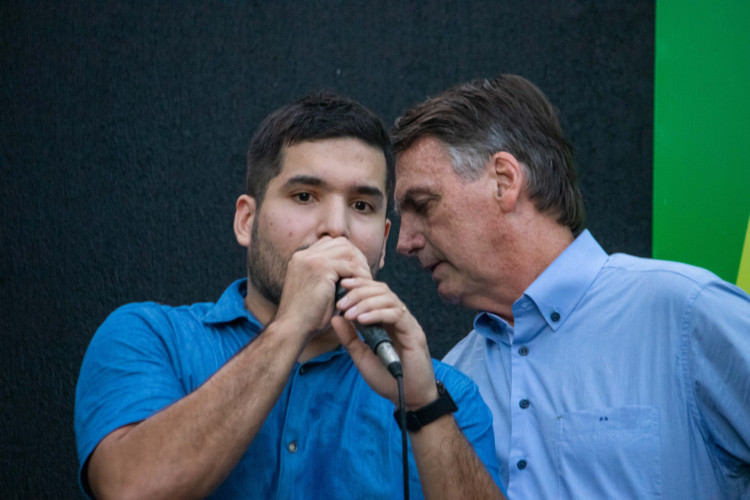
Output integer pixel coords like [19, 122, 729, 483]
[557, 406, 661, 499]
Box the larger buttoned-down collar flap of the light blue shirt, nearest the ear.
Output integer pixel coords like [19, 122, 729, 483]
[516, 229, 608, 331]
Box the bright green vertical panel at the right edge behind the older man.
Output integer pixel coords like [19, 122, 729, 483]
[653, 0, 750, 282]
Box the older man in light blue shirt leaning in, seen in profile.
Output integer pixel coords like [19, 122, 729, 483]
[394, 75, 750, 499]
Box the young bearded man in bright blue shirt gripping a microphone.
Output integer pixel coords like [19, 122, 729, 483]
[75, 94, 501, 498]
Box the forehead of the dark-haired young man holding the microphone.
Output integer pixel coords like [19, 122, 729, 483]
[274, 137, 386, 191]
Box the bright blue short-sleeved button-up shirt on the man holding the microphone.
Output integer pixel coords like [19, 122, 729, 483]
[75, 280, 497, 500]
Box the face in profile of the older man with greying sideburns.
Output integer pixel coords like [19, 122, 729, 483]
[395, 137, 500, 307]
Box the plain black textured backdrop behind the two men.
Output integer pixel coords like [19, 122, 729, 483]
[0, 0, 654, 498]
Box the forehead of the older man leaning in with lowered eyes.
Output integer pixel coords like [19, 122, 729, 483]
[395, 137, 457, 202]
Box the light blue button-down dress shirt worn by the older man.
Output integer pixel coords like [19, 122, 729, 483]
[444, 231, 750, 499]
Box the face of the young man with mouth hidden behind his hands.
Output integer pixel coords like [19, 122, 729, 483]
[248, 138, 390, 304]
